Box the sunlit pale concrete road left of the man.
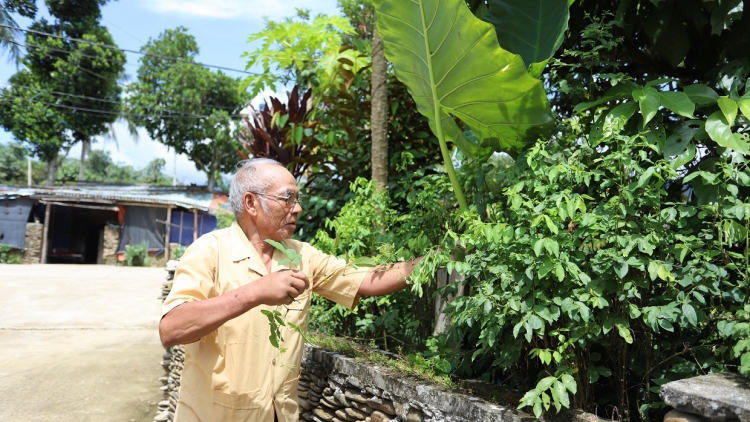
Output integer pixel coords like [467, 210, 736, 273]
[0, 265, 166, 422]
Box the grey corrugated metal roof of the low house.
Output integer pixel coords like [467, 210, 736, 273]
[0, 186, 223, 212]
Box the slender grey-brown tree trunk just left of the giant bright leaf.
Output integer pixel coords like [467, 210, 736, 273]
[370, 27, 388, 189]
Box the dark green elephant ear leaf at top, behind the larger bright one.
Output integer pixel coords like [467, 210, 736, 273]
[479, 0, 570, 77]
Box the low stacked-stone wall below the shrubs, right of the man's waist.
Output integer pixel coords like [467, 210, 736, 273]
[299, 345, 535, 422]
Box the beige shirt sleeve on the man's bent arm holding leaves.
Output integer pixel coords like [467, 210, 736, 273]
[161, 236, 218, 316]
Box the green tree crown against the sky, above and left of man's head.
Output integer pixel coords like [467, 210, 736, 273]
[128, 27, 249, 190]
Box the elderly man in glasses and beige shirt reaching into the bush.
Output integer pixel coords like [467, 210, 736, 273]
[159, 159, 416, 422]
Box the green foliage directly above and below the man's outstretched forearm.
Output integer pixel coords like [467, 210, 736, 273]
[310, 175, 450, 351]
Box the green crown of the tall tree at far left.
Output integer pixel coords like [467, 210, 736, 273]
[0, 0, 125, 185]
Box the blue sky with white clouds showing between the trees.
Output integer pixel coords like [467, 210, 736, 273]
[0, 0, 339, 185]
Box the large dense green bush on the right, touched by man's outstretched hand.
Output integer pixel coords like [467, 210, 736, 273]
[418, 94, 750, 420]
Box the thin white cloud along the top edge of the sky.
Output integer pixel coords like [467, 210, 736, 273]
[141, 0, 338, 20]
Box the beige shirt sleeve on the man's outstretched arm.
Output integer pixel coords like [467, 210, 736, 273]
[305, 246, 370, 309]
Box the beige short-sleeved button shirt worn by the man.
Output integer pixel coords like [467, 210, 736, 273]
[162, 223, 367, 422]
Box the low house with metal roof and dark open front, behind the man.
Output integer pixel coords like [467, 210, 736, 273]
[0, 185, 228, 264]
